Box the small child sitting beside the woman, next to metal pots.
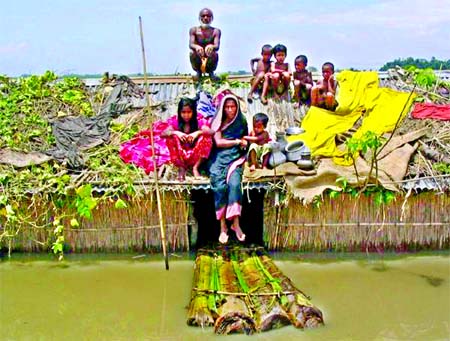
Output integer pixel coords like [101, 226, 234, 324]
[244, 113, 270, 172]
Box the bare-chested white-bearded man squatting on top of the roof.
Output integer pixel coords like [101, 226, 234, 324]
[189, 8, 221, 80]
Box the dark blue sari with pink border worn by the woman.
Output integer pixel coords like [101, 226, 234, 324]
[209, 95, 248, 220]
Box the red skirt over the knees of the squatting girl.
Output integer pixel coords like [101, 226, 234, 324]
[166, 135, 212, 169]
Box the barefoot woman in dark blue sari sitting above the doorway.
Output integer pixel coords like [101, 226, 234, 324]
[209, 94, 248, 244]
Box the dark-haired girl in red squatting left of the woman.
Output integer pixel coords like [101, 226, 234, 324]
[161, 97, 214, 181]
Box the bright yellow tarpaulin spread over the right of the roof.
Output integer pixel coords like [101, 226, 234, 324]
[289, 71, 415, 165]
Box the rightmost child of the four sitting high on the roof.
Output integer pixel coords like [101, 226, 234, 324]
[311, 62, 337, 110]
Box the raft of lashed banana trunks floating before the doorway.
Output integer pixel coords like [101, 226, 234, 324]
[187, 247, 324, 334]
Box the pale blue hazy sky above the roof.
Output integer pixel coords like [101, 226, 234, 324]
[0, 0, 450, 76]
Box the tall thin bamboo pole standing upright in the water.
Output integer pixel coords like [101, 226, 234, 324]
[139, 16, 169, 270]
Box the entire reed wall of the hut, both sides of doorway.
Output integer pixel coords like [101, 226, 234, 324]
[0, 191, 450, 252]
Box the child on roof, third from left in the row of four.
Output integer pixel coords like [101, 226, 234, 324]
[293, 55, 313, 108]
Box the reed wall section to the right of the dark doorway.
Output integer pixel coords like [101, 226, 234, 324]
[265, 192, 450, 251]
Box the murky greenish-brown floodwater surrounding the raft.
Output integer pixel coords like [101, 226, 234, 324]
[0, 253, 450, 340]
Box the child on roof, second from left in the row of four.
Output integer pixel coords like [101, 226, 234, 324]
[261, 44, 291, 104]
